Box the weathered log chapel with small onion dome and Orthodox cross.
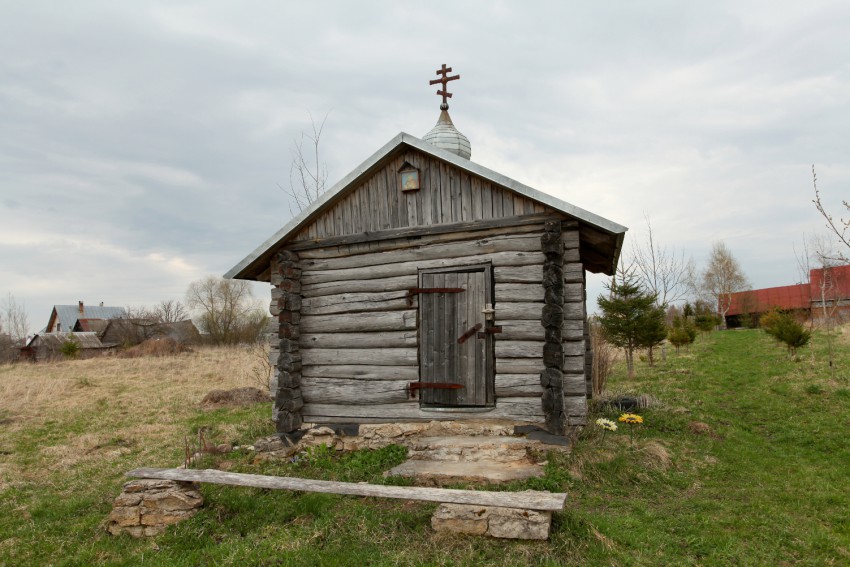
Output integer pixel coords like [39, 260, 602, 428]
[226, 65, 626, 435]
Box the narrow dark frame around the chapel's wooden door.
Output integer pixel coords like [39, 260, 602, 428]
[416, 262, 496, 411]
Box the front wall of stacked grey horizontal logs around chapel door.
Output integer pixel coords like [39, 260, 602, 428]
[272, 219, 587, 432]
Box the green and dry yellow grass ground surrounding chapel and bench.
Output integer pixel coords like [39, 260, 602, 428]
[0, 330, 850, 565]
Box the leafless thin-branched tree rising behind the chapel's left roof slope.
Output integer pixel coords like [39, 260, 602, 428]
[281, 114, 328, 211]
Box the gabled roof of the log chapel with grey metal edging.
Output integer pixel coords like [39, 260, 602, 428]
[224, 132, 628, 279]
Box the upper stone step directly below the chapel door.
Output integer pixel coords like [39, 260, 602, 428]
[406, 435, 543, 462]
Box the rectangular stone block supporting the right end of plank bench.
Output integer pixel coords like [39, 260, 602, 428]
[431, 504, 552, 539]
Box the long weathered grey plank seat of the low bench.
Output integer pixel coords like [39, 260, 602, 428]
[127, 468, 567, 512]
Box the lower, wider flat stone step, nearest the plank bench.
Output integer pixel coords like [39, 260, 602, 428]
[384, 459, 544, 486]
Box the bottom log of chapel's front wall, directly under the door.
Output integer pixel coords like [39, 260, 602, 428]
[301, 397, 543, 423]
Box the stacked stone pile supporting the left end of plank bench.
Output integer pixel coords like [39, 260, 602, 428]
[107, 479, 204, 537]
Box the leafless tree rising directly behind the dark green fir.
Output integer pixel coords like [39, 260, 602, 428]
[632, 215, 688, 306]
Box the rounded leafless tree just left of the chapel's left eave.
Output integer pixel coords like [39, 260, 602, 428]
[186, 276, 268, 344]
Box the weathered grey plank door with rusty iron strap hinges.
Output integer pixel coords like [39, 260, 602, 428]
[419, 266, 495, 407]
